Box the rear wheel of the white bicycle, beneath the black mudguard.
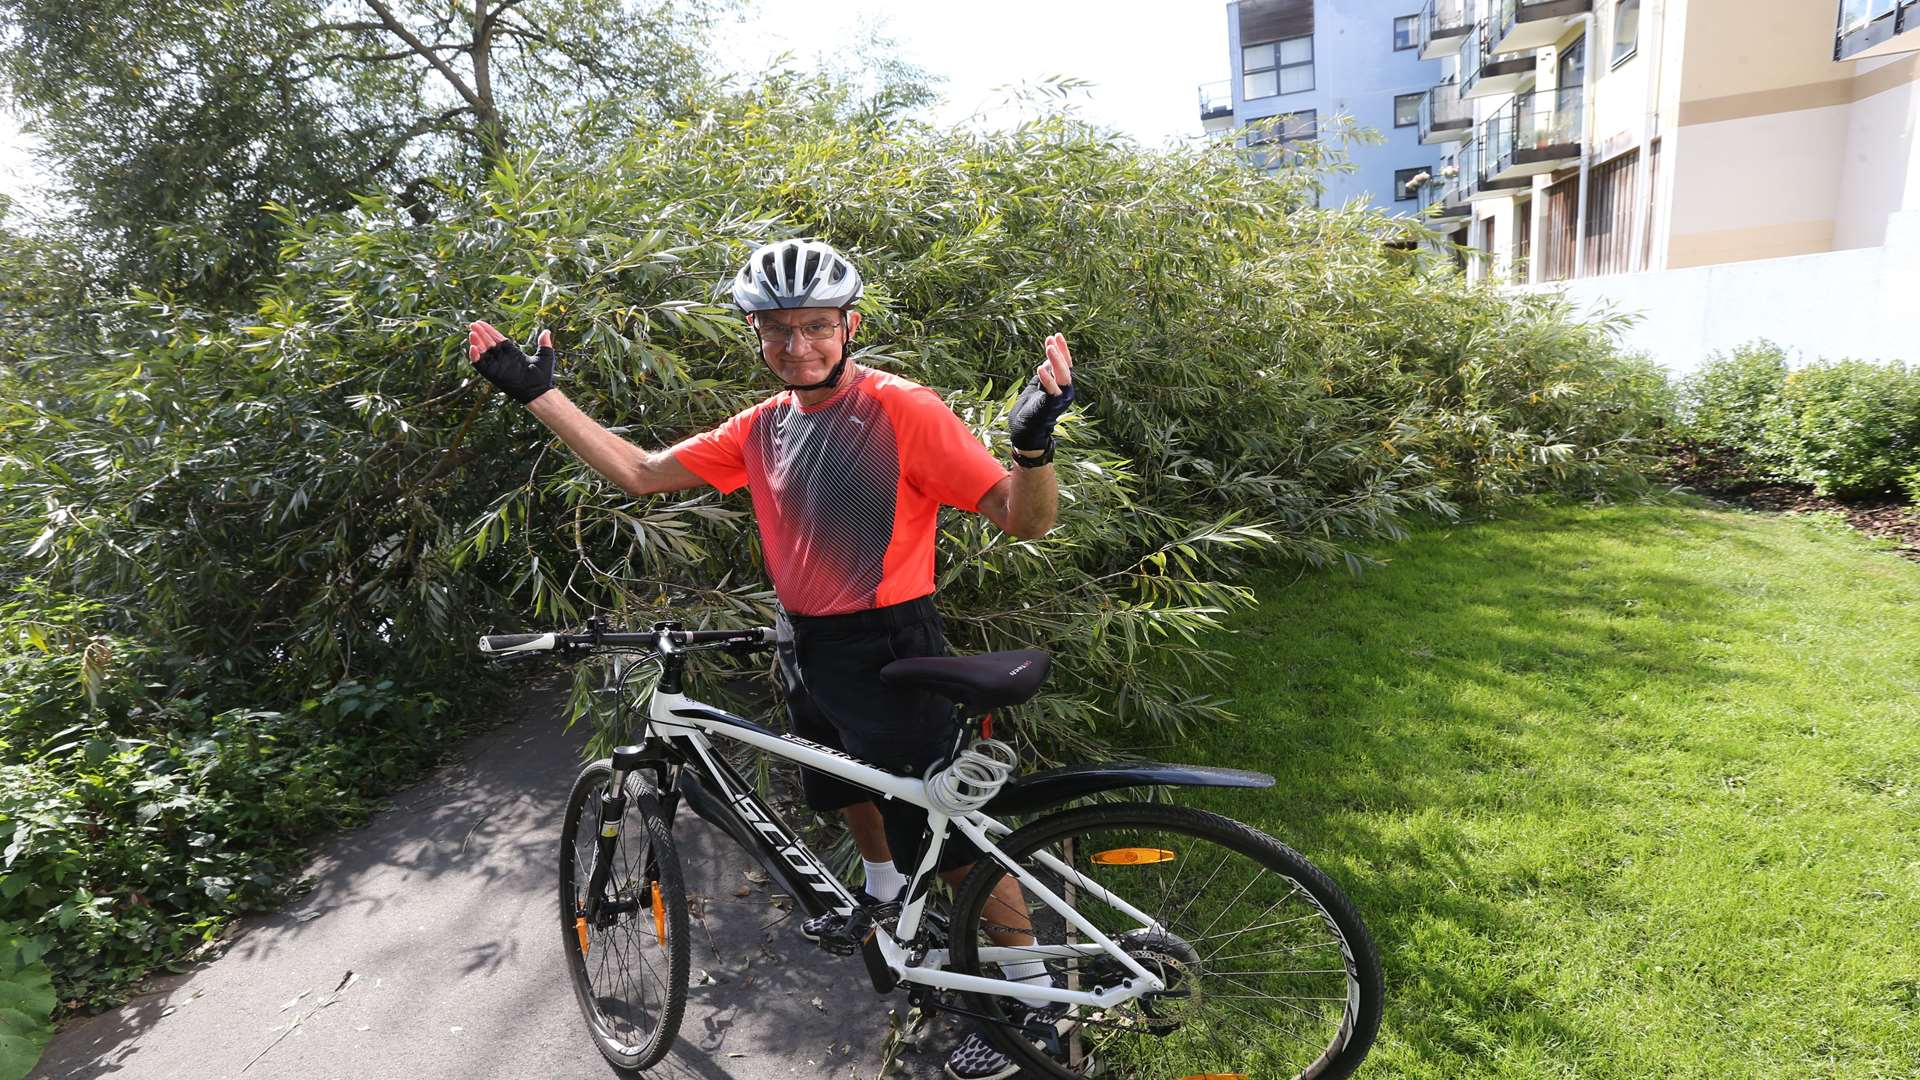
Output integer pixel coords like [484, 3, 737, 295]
[952, 803, 1384, 1080]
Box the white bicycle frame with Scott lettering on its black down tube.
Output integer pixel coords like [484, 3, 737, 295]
[637, 690, 1165, 1009]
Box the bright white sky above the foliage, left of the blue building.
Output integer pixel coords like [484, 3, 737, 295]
[0, 0, 1227, 220]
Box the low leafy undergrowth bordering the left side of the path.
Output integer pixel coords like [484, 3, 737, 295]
[0, 582, 464, 1005]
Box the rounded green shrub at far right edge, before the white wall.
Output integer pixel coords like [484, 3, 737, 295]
[1761, 359, 1920, 496]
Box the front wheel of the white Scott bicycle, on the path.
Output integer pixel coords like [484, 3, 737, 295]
[561, 761, 689, 1072]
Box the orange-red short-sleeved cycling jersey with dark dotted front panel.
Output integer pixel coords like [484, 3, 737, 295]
[672, 367, 1006, 615]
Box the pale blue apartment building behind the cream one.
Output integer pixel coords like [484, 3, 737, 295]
[1200, 0, 1440, 213]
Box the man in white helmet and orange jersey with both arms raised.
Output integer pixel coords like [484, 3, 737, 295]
[468, 240, 1073, 1080]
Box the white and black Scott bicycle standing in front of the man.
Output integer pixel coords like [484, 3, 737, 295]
[480, 621, 1382, 1080]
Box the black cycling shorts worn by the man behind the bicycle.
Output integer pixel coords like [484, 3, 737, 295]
[780, 596, 979, 876]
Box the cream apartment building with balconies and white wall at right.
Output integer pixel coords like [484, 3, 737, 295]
[1417, 0, 1920, 367]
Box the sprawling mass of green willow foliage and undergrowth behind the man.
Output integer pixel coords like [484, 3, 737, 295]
[0, 83, 1659, 1001]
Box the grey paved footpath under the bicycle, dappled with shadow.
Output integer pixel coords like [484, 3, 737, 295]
[33, 690, 960, 1080]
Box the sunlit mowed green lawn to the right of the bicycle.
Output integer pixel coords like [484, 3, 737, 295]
[1177, 505, 1920, 1080]
